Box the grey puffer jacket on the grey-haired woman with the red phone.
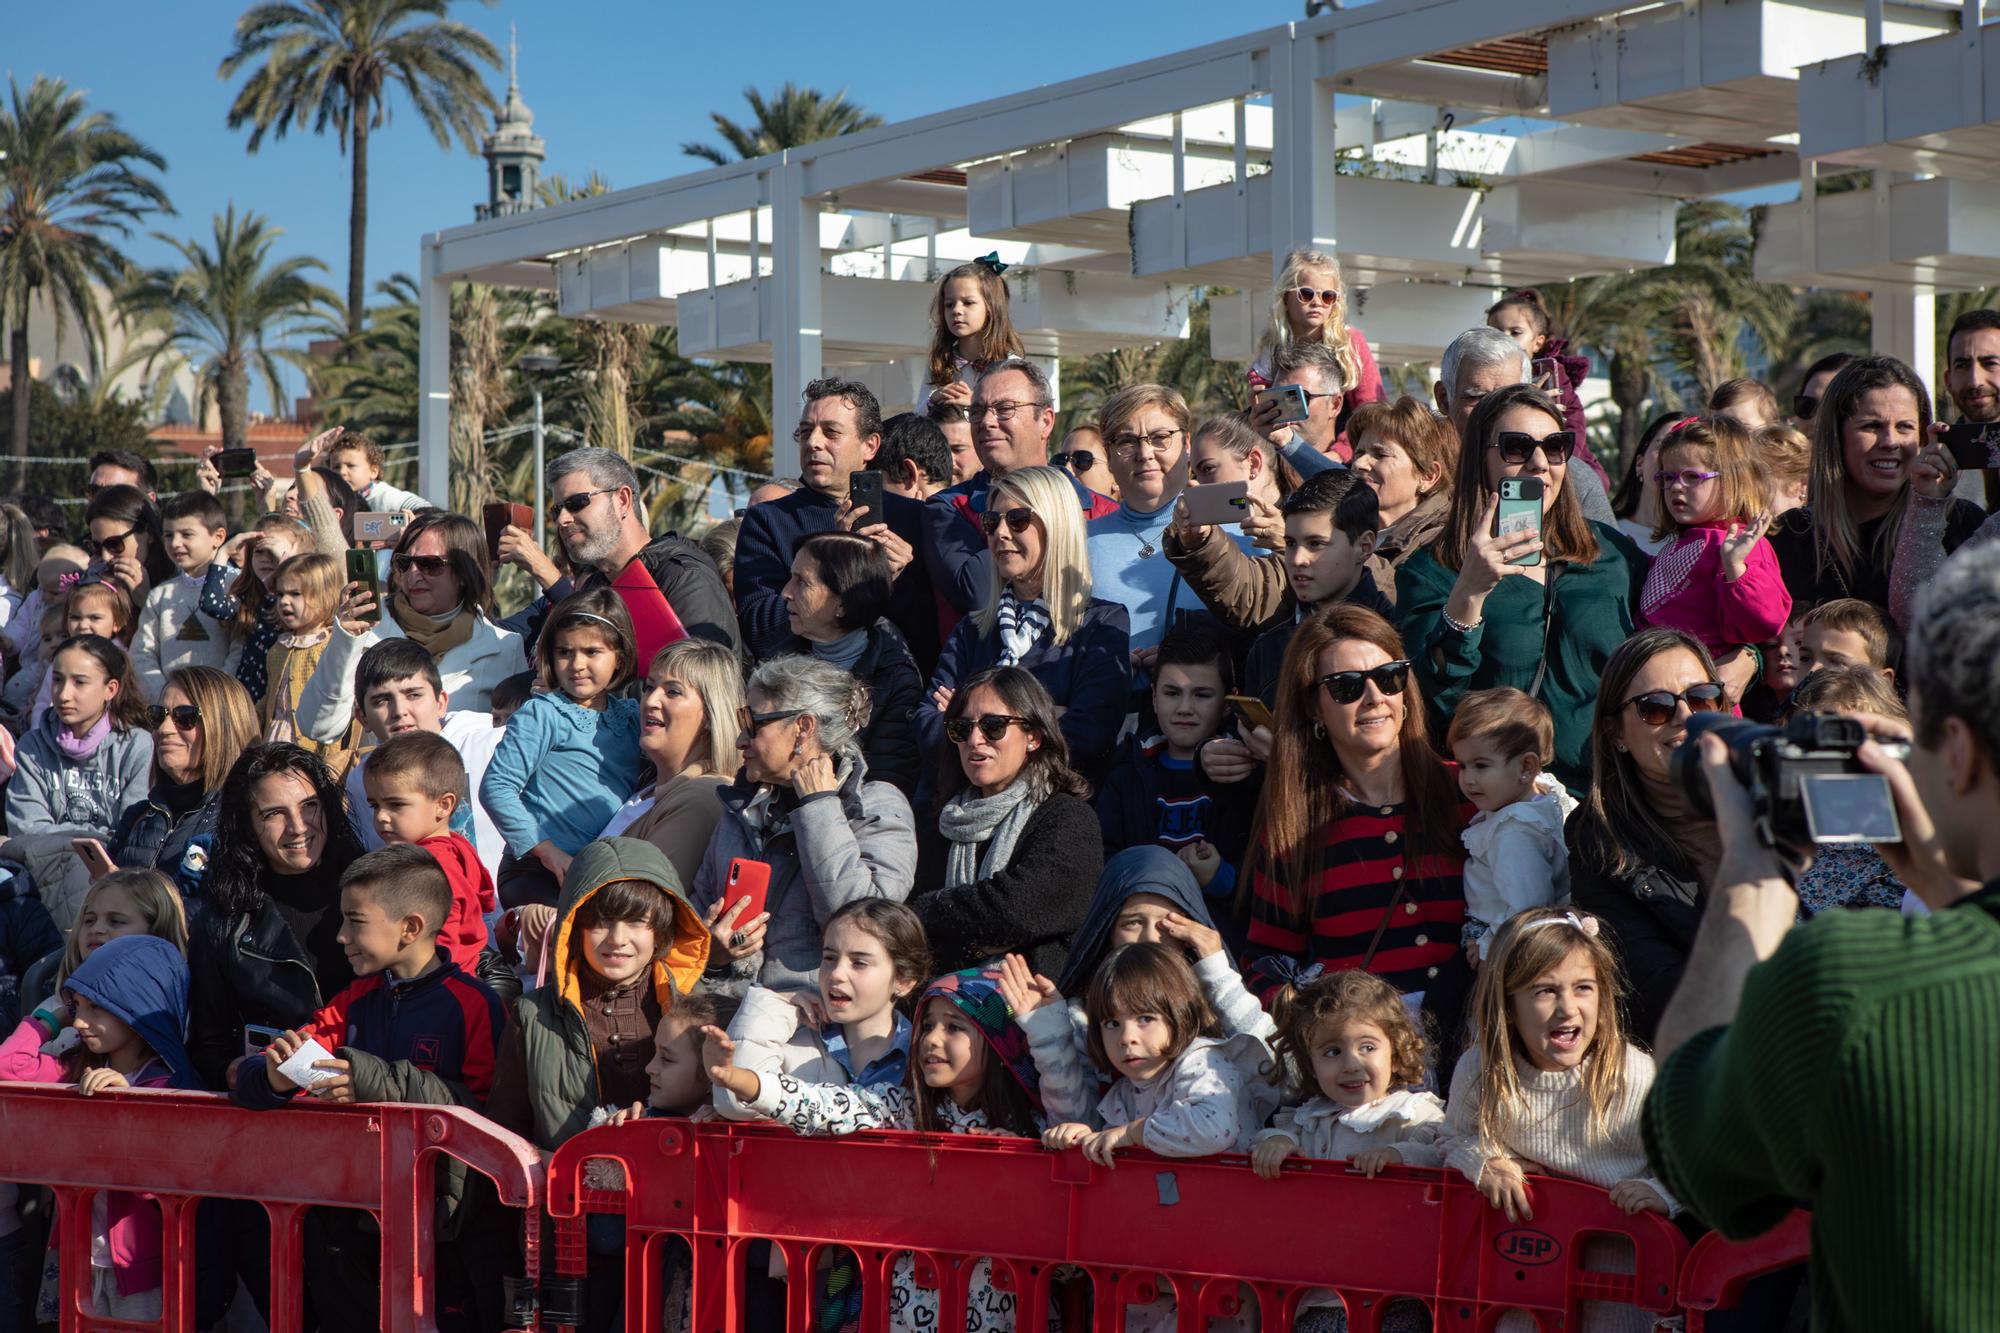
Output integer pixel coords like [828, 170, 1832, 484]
[692, 757, 916, 999]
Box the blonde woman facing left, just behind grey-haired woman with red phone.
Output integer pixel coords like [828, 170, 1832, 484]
[598, 638, 744, 885]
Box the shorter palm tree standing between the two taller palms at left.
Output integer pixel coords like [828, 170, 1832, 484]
[120, 204, 340, 448]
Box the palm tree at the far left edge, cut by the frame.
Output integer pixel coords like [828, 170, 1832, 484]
[0, 74, 174, 490]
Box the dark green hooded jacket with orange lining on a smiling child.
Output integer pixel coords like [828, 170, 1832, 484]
[486, 839, 708, 1151]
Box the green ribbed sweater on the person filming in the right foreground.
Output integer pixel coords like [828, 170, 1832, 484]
[1644, 881, 2000, 1333]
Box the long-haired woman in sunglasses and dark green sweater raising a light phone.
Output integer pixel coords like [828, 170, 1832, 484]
[1396, 384, 1646, 795]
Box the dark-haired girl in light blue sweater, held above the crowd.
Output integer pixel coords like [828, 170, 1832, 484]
[480, 588, 648, 907]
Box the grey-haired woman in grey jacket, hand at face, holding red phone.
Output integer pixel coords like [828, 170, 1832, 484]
[692, 656, 916, 997]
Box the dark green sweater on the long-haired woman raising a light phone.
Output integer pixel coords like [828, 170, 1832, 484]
[1396, 522, 1646, 797]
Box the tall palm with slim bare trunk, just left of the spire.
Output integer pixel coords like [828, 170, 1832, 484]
[220, 0, 500, 336]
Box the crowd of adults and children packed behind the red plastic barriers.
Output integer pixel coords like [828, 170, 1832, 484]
[0, 250, 2000, 1331]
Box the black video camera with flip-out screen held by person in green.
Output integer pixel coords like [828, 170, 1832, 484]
[1674, 713, 1902, 857]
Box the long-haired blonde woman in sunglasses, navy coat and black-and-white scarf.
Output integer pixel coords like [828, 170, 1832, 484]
[916, 466, 1132, 775]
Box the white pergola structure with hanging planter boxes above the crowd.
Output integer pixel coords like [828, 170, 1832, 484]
[406, 0, 2000, 494]
